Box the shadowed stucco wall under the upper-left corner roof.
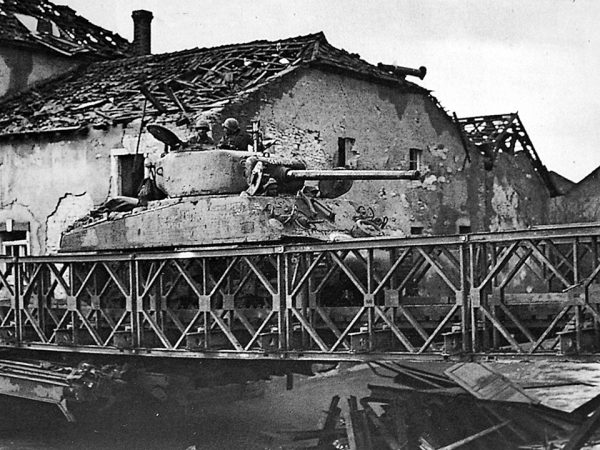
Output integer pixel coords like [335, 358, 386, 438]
[0, 46, 79, 97]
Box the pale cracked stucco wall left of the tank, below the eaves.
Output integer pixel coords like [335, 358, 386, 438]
[0, 128, 117, 254]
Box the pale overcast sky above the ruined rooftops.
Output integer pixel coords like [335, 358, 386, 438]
[54, 0, 600, 181]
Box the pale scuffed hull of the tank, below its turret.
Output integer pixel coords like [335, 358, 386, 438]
[61, 195, 355, 252]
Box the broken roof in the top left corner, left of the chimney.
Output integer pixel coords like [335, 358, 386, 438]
[0, 0, 131, 59]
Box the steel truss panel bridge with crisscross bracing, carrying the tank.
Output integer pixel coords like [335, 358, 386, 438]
[0, 223, 600, 361]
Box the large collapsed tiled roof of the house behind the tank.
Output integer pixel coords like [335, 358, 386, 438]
[0, 32, 435, 136]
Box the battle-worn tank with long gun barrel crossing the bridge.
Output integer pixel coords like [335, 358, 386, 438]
[61, 125, 419, 252]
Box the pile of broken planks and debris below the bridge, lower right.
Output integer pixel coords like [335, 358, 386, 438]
[273, 363, 600, 450]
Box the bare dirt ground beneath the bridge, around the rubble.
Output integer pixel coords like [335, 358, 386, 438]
[0, 361, 600, 450]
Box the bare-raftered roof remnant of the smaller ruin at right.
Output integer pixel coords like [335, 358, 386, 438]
[458, 112, 560, 197]
